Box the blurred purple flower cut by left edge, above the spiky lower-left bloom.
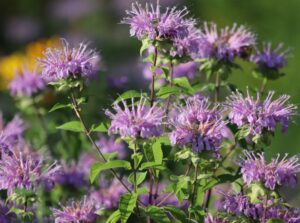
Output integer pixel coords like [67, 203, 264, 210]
[0, 112, 26, 145]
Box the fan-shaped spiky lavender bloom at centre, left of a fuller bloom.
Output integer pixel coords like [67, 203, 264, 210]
[105, 97, 164, 139]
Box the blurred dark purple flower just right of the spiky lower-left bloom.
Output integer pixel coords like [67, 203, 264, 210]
[55, 162, 87, 188]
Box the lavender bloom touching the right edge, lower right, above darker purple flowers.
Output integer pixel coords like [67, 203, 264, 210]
[240, 152, 300, 190]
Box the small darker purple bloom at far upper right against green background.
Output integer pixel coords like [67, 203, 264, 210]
[250, 43, 290, 70]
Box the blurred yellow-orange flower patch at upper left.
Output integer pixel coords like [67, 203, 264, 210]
[0, 37, 59, 90]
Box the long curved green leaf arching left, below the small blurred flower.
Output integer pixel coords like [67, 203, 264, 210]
[90, 160, 131, 183]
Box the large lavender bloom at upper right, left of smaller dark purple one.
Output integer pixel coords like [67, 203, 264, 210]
[199, 23, 256, 62]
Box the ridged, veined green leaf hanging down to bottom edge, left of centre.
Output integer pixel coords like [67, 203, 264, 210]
[119, 193, 138, 223]
